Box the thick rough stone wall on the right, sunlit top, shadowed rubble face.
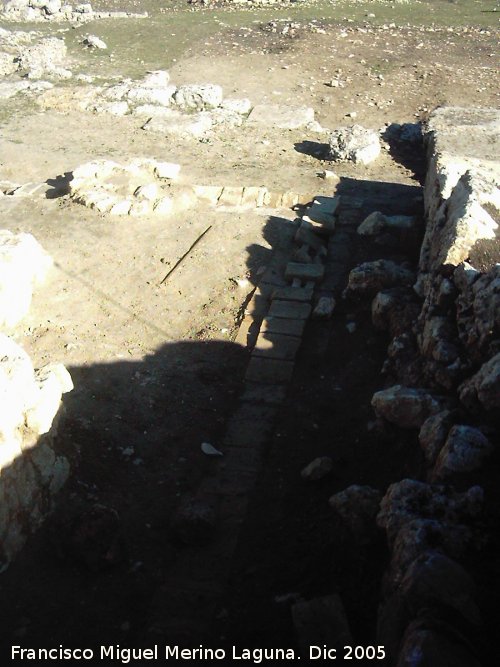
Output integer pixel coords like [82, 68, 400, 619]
[372, 108, 500, 667]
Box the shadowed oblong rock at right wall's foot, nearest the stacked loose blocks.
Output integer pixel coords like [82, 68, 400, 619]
[347, 259, 415, 295]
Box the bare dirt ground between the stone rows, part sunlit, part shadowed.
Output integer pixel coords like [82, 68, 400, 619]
[0, 0, 498, 664]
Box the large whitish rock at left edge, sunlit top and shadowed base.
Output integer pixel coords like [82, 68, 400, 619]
[0, 334, 73, 570]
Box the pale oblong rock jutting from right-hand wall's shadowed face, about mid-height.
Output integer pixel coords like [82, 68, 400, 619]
[372, 385, 442, 428]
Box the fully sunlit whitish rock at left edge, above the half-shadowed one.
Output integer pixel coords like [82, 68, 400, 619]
[0, 229, 53, 328]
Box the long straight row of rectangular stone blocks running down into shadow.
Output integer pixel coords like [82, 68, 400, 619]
[150, 193, 338, 623]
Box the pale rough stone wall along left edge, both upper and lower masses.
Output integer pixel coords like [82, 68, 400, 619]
[0, 230, 73, 572]
